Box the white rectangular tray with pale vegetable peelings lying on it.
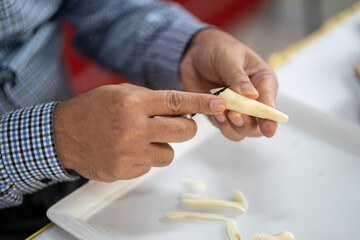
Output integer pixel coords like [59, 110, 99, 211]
[47, 96, 360, 240]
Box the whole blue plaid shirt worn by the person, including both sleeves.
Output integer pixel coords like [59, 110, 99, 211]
[0, 0, 206, 208]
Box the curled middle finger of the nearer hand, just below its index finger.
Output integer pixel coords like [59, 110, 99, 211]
[148, 117, 197, 143]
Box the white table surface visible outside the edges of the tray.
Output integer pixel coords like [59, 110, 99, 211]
[34, 6, 360, 240]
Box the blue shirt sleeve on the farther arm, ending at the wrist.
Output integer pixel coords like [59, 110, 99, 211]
[60, 0, 208, 89]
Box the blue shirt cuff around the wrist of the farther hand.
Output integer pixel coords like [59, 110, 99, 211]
[145, 16, 214, 89]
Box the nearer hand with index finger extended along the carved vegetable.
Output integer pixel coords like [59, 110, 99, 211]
[54, 84, 225, 182]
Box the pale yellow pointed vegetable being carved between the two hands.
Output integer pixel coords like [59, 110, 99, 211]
[210, 88, 289, 122]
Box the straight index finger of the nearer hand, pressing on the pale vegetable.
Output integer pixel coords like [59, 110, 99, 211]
[145, 90, 225, 116]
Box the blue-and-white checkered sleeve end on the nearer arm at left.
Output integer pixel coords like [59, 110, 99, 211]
[0, 102, 76, 208]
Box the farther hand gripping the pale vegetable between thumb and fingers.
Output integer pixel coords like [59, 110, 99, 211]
[180, 29, 278, 141]
